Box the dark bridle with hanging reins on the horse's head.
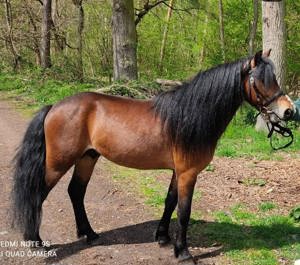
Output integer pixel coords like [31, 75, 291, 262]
[248, 70, 294, 150]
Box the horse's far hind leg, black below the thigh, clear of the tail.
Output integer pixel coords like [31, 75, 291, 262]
[68, 150, 99, 243]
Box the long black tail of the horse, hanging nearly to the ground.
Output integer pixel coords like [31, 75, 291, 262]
[12, 106, 51, 241]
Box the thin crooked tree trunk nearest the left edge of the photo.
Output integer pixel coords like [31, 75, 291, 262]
[4, 0, 21, 70]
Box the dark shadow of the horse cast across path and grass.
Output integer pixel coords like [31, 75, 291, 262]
[45, 219, 300, 262]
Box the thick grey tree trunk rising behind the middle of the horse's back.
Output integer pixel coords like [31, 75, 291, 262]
[112, 0, 137, 80]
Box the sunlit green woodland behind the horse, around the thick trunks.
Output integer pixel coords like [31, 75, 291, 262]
[0, 0, 300, 96]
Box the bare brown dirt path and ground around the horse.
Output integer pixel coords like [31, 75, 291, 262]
[0, 101, 300, 265]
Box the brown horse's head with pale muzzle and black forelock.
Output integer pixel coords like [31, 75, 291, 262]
[244, 49, 295, 123]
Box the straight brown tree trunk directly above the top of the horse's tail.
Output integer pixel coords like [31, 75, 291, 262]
[40, 0, 52, 69]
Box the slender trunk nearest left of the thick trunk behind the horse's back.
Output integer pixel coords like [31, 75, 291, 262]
[73, 0, 84, 82]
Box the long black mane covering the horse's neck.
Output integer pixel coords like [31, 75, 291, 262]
[153, 58, 249, 153]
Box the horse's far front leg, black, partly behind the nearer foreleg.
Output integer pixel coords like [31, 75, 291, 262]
[155, 171, 178, 245]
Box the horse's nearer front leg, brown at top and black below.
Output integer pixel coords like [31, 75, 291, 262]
[174, 169, 198, 264]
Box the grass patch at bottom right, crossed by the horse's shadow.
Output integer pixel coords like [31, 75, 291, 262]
[189, 205, 300, 265]
